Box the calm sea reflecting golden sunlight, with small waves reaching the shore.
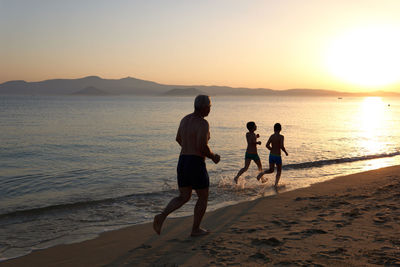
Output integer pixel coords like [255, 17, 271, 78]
[0, 95, 400, 261]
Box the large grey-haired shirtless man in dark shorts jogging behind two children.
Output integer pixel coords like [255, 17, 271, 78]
[153, 95, 220, 236]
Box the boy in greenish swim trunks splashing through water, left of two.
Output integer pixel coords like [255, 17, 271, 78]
[234, 121, 264, 184]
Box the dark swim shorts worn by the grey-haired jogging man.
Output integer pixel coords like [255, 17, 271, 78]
[177, 155, 210, 189]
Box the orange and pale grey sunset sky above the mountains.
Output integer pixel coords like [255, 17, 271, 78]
[0, 0, 400, 92]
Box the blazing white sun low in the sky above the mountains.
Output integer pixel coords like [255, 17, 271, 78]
[326, 26, 400, 89]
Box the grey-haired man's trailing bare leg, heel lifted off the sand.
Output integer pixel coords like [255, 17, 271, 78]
[153, 186, 192, 234]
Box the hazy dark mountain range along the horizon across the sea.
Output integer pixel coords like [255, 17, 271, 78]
[0, 76, 400, 97]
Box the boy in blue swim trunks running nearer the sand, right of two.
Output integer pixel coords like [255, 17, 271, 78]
[257, 123, 289, 188]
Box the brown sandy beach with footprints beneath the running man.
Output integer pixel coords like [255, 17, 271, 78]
[0, 166, 400, 266]
